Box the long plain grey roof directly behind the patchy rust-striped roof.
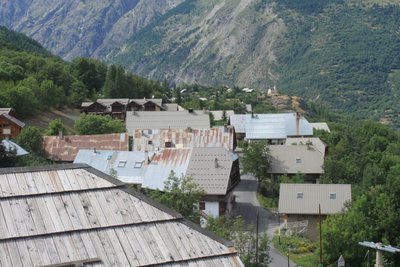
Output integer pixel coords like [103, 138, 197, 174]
[126, 111, 210, 136]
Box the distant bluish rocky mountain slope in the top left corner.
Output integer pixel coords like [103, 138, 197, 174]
[0, 0, 183, 60]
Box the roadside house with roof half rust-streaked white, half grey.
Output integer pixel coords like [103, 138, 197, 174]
[142, 147, 240, 221]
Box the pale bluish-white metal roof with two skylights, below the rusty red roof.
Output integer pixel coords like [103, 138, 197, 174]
[74, 149, 153, 184]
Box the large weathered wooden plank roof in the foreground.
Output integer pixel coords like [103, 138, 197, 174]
[0, 164, 243, 266]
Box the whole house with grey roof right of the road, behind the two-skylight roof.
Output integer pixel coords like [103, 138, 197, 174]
[268, 137, 327, 183]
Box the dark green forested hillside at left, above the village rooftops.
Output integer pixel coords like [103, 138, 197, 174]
[0, 27, 168, 118]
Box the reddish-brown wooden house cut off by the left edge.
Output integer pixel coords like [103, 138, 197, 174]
[0, 108, 25, 139]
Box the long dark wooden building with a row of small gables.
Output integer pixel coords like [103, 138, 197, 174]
[81, 98, 179, 120]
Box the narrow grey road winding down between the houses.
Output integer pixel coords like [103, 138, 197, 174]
[234, 175, 296, 267]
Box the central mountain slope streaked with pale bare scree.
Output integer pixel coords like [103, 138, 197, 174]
[108, 0, 285, 88]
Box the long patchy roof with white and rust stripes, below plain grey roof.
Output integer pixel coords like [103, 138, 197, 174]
[132, 126, 235, 151]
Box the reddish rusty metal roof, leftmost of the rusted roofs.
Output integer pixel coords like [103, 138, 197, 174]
[43, 133, 129, 162]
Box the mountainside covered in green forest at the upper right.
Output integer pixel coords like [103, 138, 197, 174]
[277, 0, 400, 127]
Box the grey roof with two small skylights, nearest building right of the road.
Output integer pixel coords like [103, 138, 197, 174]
[279, 184, 351, 214]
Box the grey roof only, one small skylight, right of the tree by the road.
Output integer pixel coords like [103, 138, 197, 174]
[269, 139, 325, 174]
